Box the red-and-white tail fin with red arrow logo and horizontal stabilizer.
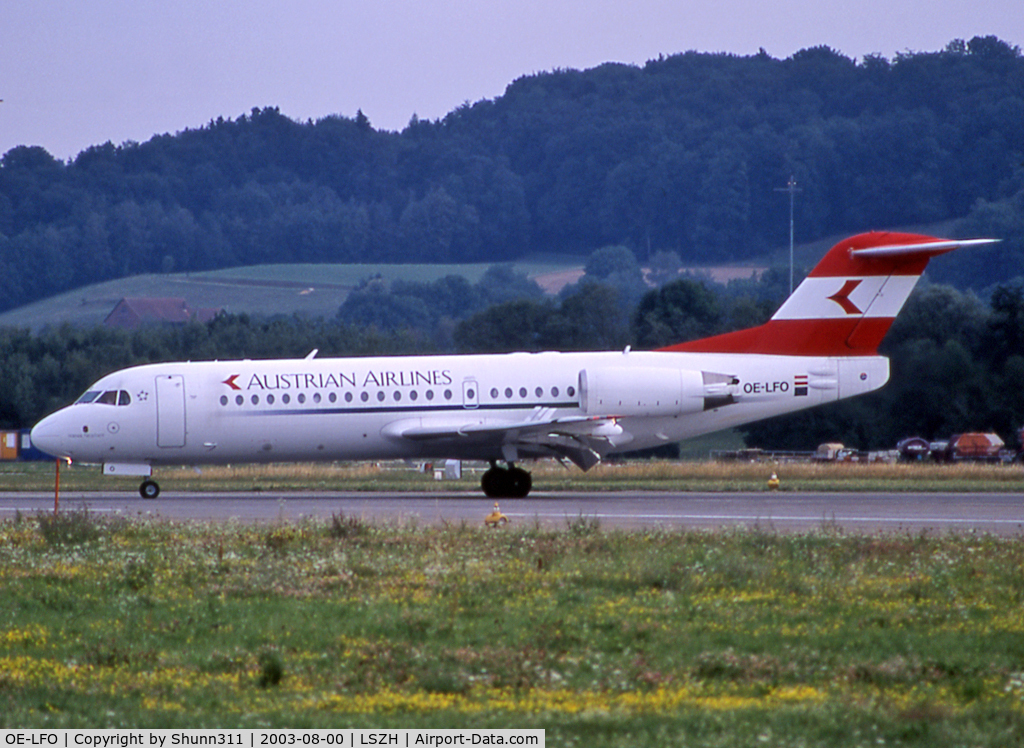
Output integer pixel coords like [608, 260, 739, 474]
[662, 232, 997, 356]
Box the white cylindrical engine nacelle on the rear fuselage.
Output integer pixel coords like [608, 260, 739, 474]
[580, 366, 705, 416]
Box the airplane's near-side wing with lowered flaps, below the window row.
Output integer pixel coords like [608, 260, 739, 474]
[383, 408, 633, 470]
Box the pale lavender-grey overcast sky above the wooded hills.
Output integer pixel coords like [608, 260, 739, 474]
[6, 0, 1024, 159]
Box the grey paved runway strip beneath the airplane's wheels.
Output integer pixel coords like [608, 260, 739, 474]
[0, 492, 1024, 536]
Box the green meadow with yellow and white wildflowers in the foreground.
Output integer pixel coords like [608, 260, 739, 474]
[0, 512, 1024, 748]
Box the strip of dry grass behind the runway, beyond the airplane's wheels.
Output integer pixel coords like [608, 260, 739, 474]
[0, 460, 1024, 494]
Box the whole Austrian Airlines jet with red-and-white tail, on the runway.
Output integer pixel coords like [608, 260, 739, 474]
[31, 232, 997, 499]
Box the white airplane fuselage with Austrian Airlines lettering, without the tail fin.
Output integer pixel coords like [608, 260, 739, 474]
[32, 350, 889, 472]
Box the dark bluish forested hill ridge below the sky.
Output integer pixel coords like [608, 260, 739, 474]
[0, 32, 1024, 308]
